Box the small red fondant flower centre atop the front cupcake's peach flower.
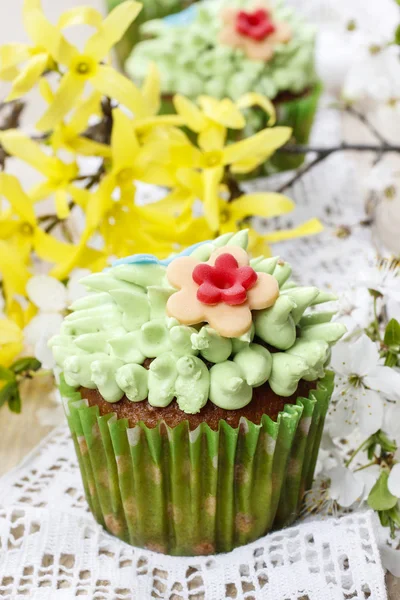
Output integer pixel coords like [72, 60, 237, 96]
[192, 254, 257, 305]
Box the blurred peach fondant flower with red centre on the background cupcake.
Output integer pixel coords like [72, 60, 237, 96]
[219, 4, 292, 62]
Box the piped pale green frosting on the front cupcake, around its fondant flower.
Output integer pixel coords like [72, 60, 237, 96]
[49, 230, 345, 414]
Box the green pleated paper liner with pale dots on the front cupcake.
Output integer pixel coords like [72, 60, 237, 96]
[60, 372, 333, 556]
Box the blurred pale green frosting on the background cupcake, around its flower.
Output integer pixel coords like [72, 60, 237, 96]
[125, 0, 316, 101]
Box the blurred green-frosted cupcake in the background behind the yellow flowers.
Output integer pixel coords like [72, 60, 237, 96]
[125, 0, 321, 173]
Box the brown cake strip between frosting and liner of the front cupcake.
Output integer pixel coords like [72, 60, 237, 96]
[80, 381, 317, 431]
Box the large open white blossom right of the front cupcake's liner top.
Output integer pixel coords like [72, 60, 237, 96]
[329, 335, 400, 437]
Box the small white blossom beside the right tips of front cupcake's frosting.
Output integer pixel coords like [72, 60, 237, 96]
[334, 287, 373, 337]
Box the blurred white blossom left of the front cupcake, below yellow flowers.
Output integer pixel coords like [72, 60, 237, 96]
[24, 269, 90, 369]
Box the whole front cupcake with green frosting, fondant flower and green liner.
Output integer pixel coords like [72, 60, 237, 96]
[50, 231, 344, 555]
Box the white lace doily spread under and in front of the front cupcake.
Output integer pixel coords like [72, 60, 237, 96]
[0, 427, 386, 600]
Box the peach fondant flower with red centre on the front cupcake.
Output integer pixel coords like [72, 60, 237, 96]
[167, 246, 279, 338]
